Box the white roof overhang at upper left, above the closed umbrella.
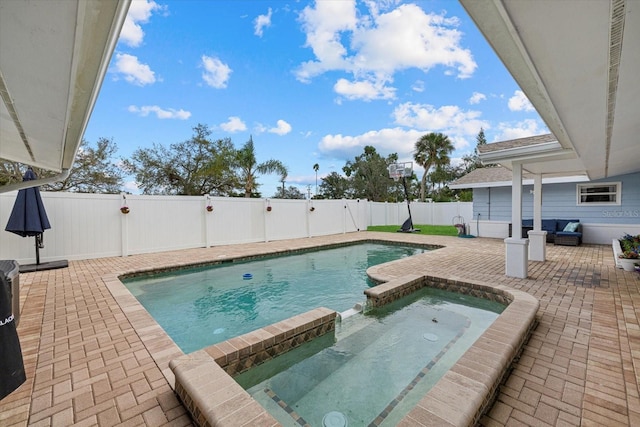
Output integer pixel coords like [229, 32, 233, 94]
[0, 0, 131, 192]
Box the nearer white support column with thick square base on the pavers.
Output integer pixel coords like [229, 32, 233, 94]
[504, 163, 529, 279]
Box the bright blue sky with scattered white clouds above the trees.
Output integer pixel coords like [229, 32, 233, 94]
[84, 0, 548, 197]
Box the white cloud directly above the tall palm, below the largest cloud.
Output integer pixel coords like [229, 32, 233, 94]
[393, 102, 491, 149]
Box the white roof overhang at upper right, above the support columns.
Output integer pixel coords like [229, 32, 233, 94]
[460, 0, 640, 179]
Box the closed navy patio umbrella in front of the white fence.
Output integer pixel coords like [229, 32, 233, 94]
[5, 168, 51, 264]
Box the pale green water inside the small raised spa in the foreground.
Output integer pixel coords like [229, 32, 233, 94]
[235, 289, 504, 427]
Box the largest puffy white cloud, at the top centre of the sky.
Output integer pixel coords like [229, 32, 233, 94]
[296, 0, 477, 99]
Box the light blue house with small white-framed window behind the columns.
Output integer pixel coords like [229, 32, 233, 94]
[449, 134, 640, 244]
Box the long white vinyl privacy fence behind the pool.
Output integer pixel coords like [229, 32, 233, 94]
[0, 192, 472, 264]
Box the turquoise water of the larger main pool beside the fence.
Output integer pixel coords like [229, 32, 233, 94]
[124, 243, 428, 353]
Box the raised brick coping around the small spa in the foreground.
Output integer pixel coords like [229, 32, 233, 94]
[170, 274, 539, 426]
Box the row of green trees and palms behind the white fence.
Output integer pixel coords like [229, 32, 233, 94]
[0, 124, 486, 202]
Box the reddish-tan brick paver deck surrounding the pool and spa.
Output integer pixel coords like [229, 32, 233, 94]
[0, 232, 640, 426]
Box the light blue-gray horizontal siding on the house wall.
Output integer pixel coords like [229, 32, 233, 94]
[473, 173, 640, 224]
